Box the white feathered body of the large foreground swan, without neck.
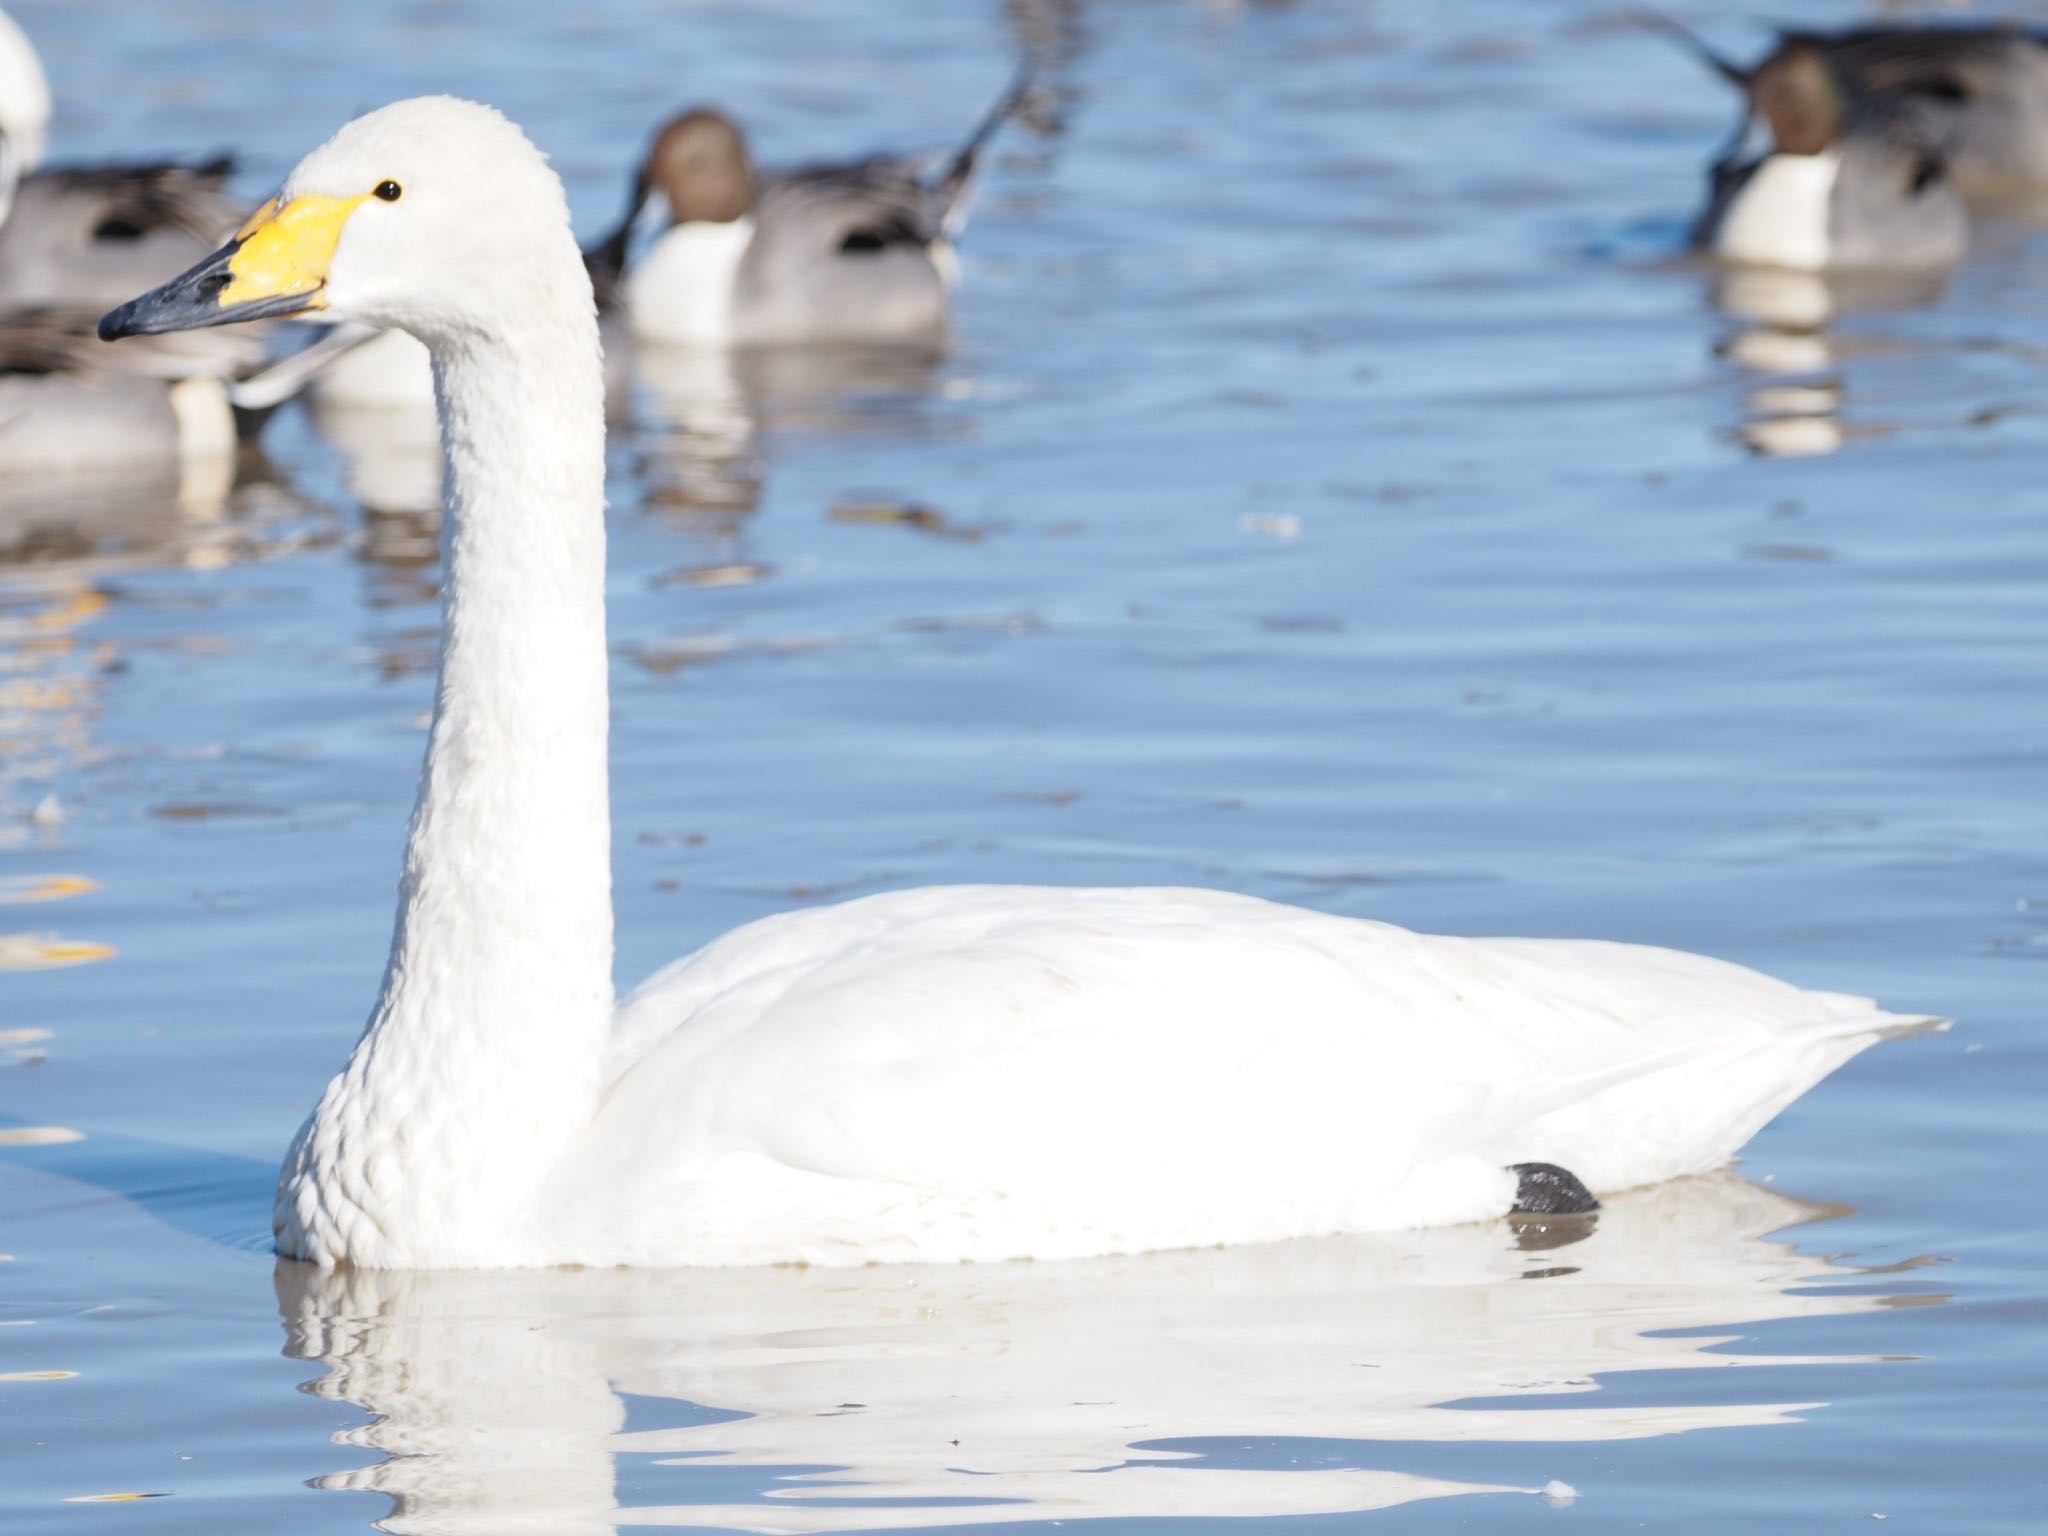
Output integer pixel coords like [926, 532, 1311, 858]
[573, 887, 1888, 1255]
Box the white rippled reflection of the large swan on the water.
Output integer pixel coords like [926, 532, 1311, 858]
[276, 1174, 1916, 1536]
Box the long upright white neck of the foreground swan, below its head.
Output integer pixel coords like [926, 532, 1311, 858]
[279, 268, 612, 1266]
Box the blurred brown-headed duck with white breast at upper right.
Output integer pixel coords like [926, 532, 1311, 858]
[1681, 33, 1970, 272]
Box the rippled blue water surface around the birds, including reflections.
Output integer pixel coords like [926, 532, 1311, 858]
[0, 0, 2048, 1536]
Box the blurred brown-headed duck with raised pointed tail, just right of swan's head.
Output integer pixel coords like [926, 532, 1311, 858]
[590, 74, 1030, 346]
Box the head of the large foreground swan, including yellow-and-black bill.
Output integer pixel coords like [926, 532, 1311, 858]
[100, 96, 590, 344]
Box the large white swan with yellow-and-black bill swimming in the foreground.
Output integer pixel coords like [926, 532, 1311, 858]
[102, 98, 1909, 1268]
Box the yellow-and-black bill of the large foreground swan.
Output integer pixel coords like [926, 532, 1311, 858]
[100, 195, 362, 342]
